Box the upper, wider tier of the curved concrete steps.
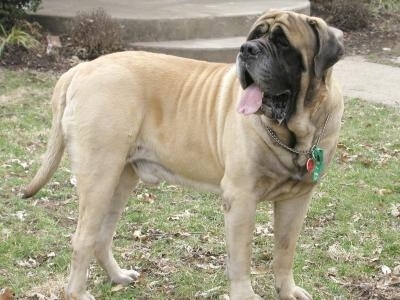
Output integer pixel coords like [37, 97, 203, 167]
[34, 0, 310, 42]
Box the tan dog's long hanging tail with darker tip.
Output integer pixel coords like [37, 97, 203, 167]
[22, 68, 76, 198]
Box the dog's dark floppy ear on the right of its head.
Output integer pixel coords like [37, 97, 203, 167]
[308, 18, 344, 78]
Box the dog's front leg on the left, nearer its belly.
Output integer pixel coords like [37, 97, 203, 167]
[223, 189, 259, 300]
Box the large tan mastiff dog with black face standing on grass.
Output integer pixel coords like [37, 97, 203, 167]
[24, 12, 343, 300]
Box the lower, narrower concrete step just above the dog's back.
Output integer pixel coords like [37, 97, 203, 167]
[130, 36, 246, 63]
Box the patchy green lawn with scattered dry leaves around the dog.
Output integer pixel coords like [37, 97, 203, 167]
[0, 69, 400, 299]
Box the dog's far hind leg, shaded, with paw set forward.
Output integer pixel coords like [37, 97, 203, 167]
[94, 165, 139, 284]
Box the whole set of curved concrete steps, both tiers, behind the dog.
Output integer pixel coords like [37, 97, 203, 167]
[34, 0, 310, 62]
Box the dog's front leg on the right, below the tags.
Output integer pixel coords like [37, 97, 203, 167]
[273, 193, 312, 300]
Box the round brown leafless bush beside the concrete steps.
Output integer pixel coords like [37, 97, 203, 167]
[70, 8, 122, 59]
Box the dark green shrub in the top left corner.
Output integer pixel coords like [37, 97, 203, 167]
[0, 0, 42, 30]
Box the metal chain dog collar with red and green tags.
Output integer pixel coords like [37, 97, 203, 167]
[265, 113, 331, 182]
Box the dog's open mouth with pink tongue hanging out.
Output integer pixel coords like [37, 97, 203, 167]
[237, 66, 291, 124]
